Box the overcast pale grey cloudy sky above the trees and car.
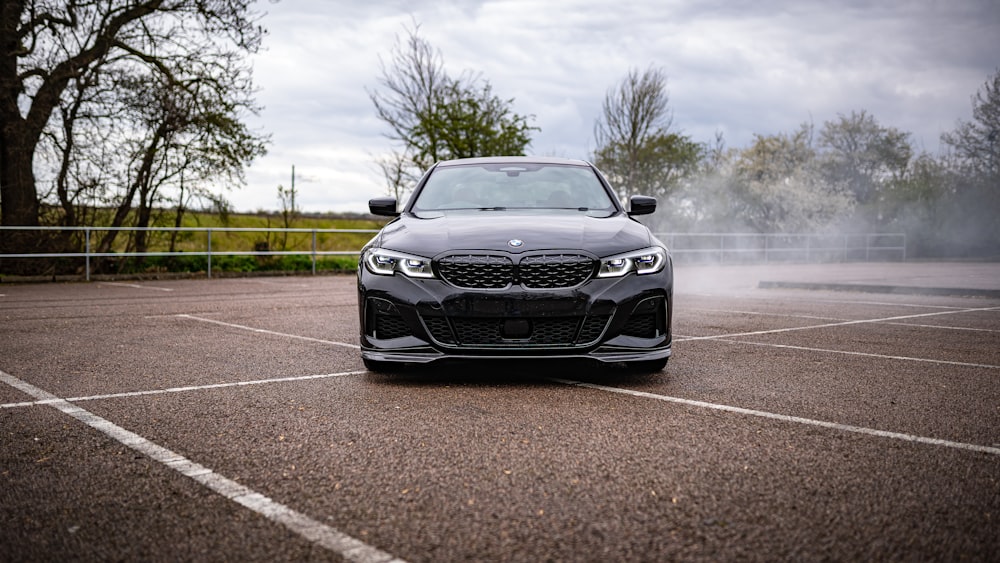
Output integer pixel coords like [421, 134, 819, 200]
[236, 0, 1000, 212]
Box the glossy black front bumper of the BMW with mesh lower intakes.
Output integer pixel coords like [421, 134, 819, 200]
[358, 265, 673, 363]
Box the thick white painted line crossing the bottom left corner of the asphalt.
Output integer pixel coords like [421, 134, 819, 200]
[0, 371, 405, 563]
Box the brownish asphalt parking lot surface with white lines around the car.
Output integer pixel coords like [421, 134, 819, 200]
[0, 263, 1000, 561]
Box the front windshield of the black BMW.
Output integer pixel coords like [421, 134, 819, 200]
[413, 163, 614, 212]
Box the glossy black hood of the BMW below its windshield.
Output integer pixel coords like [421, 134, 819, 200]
[374, 210, 653, 257]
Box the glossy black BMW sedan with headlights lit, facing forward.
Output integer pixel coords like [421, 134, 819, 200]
[358, 157, 673, 371]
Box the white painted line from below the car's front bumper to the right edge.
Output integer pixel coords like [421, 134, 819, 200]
[549, 377, 1000, 456]
